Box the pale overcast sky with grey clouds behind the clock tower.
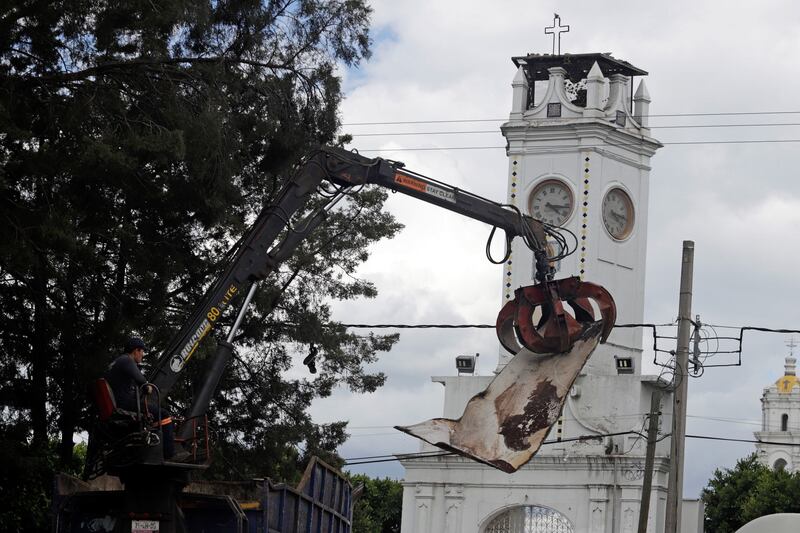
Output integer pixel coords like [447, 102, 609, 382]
[306, 0, 800, 497]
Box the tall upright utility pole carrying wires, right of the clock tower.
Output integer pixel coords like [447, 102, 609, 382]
[664, 241, 694, 533]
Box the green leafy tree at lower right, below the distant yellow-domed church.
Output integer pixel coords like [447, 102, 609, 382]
[702, 454, 800, 533]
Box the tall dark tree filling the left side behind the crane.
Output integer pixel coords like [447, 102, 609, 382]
[0, 0, 399, 528]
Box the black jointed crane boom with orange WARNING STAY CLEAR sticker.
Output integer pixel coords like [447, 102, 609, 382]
[150, 147, 545, 395]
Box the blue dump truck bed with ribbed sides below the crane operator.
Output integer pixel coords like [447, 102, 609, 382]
[53, 458, 353, 533]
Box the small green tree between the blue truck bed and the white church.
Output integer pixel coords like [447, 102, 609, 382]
[349, 474, 403, 533]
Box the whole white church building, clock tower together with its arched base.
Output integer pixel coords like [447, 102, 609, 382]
[401, 44, 698, 533]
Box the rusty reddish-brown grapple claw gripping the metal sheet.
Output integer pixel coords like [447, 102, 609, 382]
[496, 277, 617, 353]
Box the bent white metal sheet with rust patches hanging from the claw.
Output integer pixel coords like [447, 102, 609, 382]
[396, 321, 603, 473]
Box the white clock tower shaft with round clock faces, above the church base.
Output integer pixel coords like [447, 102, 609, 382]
[500, 54, 661, 375]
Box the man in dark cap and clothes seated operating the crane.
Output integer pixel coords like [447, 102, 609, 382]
[105, 337, 175, 460]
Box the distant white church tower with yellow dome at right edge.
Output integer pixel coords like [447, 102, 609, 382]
[754, 352, 800, 472]
